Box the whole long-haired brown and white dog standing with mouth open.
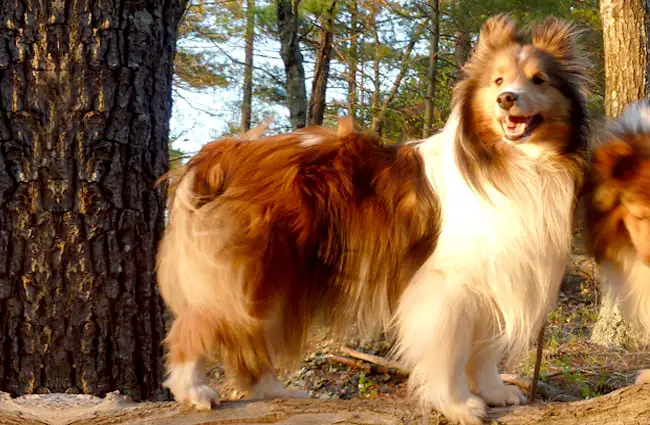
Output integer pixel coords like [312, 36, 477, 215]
[158, 16, 586, 424]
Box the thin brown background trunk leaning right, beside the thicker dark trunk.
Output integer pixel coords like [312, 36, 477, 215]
[309, 0, 336, 125]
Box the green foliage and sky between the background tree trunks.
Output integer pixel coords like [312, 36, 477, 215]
[174, 0, 604, 143]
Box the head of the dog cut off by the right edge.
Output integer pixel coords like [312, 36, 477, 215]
[589, 100, 650, 264]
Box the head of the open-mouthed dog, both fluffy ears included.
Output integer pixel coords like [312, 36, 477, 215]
[455, 16, 586, 155]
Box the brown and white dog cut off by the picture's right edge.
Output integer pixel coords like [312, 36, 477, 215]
[584, 100, 650, 383]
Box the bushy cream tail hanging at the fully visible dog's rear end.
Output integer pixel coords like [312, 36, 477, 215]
[156, 152, 252, 326]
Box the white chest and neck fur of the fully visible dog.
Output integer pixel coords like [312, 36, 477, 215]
[421, 121, 575, 355]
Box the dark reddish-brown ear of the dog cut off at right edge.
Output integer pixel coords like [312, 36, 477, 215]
[592, 139, 639, 183]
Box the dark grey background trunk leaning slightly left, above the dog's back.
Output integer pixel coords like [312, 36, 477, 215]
[276, 0, 307, 128]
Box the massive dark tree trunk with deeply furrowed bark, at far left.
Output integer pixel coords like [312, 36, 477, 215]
[0, 0, 185, 399]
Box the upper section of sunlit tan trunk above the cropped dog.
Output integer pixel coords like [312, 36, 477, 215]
[600, 0, 649, 116]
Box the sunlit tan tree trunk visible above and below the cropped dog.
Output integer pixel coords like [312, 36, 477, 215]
[592, 0, 650, 347]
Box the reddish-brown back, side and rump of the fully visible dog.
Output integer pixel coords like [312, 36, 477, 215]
[158, 122, 438, 404]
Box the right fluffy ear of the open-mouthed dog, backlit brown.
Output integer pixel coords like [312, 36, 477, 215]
[530, 17, 583, 61]
